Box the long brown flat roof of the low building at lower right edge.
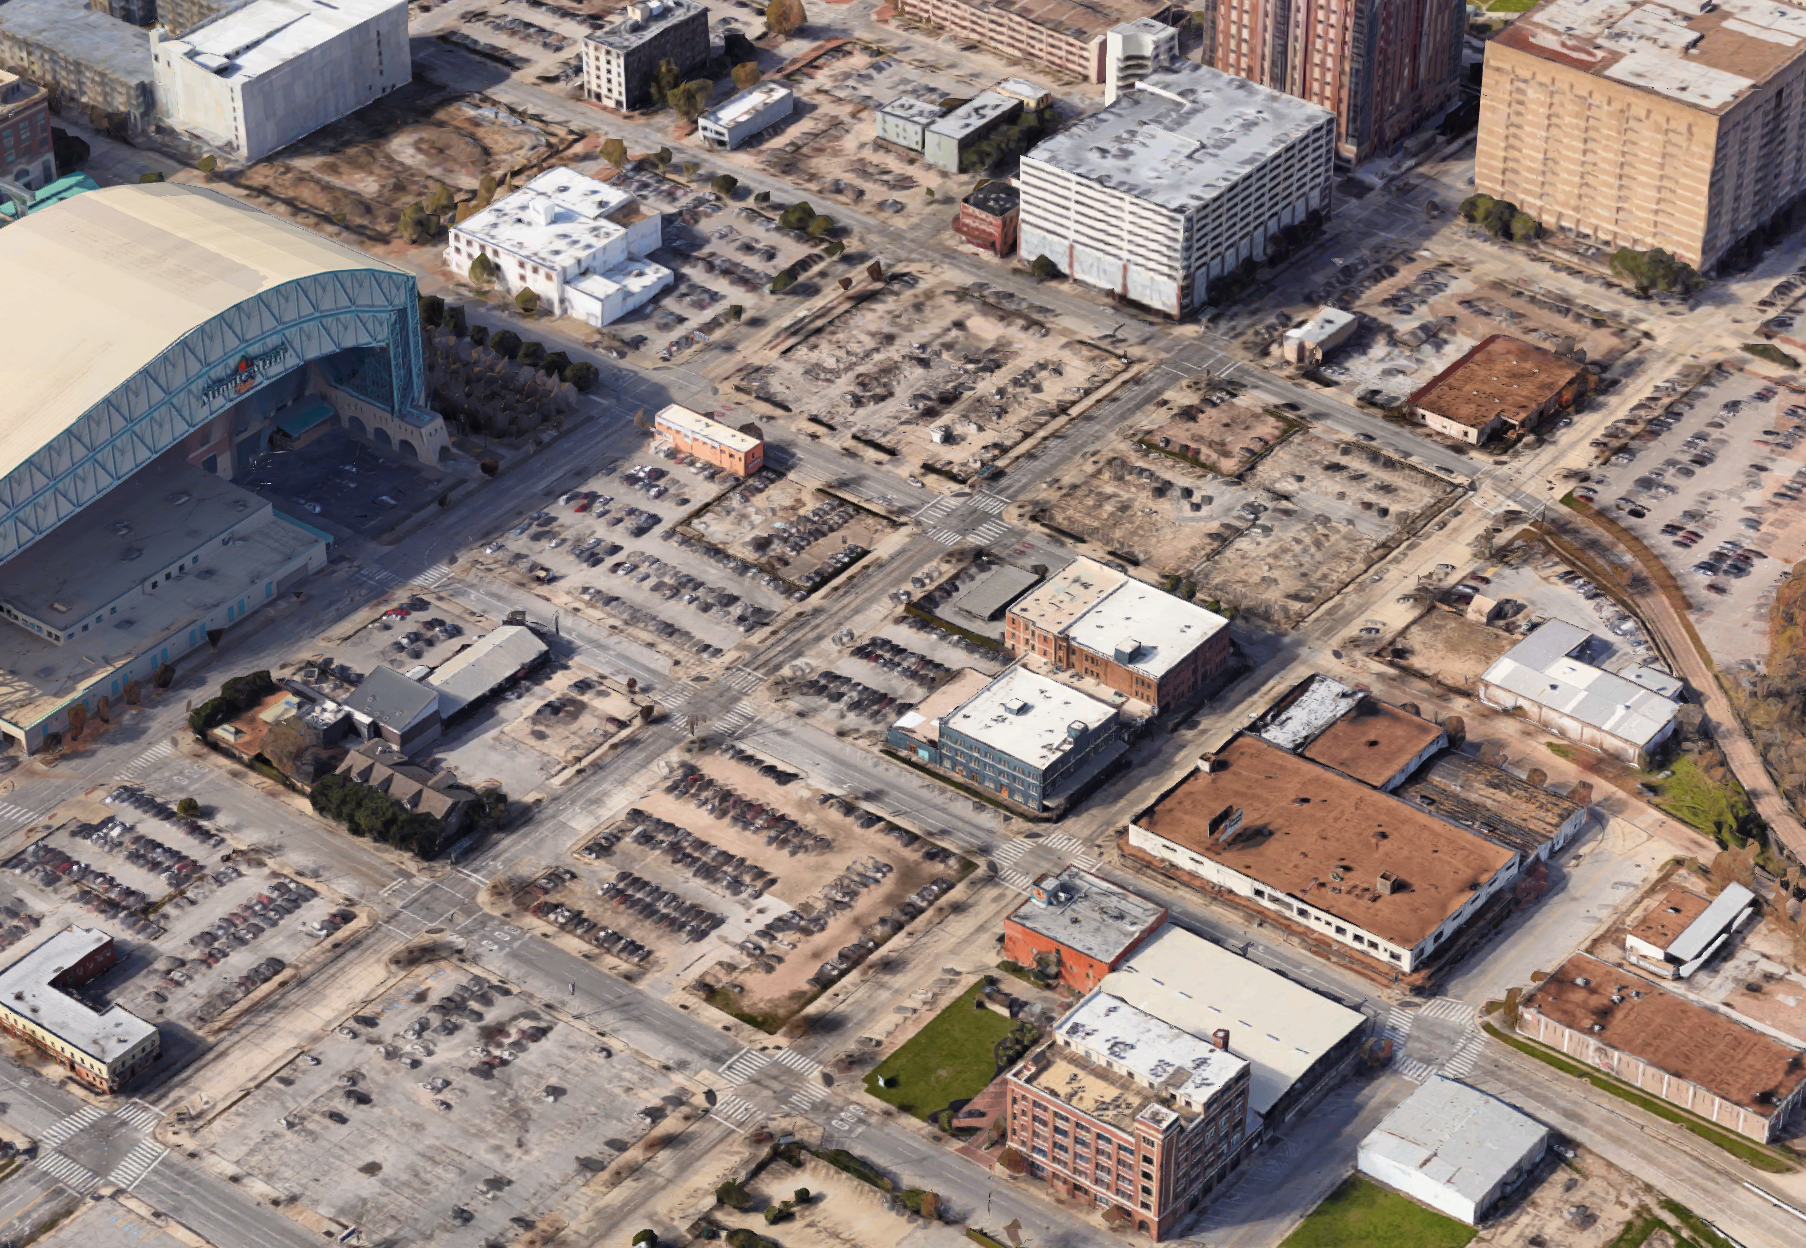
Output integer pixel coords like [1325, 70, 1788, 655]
[1524, 954, 1806, 1116]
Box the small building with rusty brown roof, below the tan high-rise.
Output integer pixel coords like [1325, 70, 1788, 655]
[1409, 334, 1593, 446]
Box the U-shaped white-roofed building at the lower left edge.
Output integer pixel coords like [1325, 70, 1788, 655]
[0, 927, 161, 1093]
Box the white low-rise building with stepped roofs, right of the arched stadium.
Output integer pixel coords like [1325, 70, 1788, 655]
[446, 166, 672, 325]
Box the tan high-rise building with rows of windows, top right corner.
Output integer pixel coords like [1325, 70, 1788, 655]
[1474, 0, 1806, 269]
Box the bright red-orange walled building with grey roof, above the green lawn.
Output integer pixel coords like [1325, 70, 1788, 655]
[1004, 867, 1167, 992]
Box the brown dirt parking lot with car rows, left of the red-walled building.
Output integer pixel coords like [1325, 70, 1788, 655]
[556, 754, 963, 1028]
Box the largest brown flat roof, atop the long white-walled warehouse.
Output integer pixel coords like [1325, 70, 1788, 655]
[1136, 737, 1515, 946]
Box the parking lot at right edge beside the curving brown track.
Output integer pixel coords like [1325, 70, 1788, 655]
[1575, 370, 1806, 663]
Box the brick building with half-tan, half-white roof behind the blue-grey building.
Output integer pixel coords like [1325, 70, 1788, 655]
[1004, 558, 1230, 712]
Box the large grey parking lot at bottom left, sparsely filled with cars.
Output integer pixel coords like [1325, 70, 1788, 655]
[197, 968, 688, 1246]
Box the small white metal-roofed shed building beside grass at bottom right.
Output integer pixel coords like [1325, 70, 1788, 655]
[1356, 1075, 1550, 1226]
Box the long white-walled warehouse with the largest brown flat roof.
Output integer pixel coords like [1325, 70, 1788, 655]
[1127, 735, 1521, 973]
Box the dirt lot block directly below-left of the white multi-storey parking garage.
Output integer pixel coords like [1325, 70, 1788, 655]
[733, 283, 1123, 479]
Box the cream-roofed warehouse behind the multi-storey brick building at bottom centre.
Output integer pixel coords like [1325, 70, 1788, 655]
[1098, 923, 1367, 1125]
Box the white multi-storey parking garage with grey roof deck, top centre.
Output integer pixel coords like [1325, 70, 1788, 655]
[1019, 61, 1336, 318]
